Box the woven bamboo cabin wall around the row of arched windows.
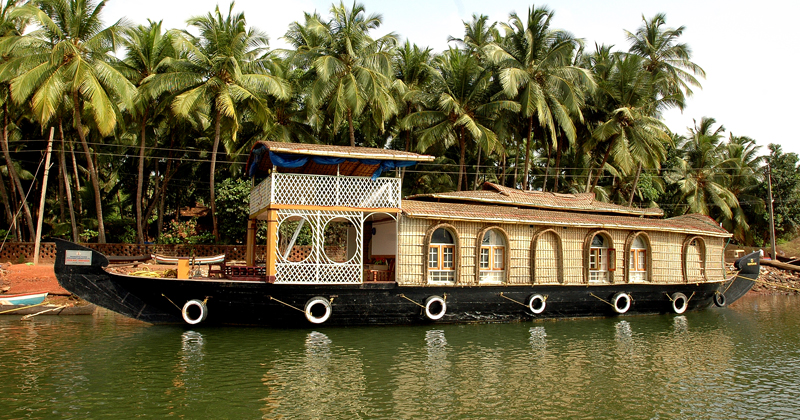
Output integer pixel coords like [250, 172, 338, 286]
[397, 216, 725, 285]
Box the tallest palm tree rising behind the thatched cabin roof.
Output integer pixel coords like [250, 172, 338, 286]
[485, 7, 594, 188]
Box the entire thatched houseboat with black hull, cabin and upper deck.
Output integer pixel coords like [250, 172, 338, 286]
[55, 142, 759, 327]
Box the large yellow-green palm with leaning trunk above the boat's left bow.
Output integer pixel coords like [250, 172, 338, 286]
[5, 0, 135, 243]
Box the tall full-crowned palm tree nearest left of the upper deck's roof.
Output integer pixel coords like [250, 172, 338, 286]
[143, 3, 290, 241]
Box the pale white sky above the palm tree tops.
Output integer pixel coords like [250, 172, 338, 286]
[103, 0, 800, 158]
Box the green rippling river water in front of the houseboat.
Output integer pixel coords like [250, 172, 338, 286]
[0, 296, 800, 419]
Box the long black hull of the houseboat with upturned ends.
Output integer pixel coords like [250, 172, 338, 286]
[55, 241, 758, 327]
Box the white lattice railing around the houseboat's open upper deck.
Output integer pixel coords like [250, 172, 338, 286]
[250, 173, 400, 214]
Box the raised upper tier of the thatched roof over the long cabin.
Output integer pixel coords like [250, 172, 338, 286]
[407, 182, 664, 217]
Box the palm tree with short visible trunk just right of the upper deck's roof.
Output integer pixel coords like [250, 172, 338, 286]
[404, 48, 519, 190]
